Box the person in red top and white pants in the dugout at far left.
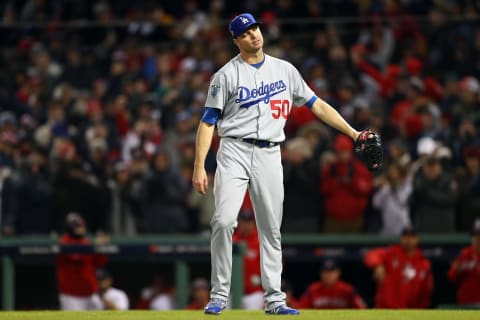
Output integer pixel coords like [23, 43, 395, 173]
[56, 212, 108, 310]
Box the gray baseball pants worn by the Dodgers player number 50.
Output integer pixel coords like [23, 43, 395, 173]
[210, 138, 285, 309]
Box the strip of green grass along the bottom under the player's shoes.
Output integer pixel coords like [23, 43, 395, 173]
[0, 310, 480, 320]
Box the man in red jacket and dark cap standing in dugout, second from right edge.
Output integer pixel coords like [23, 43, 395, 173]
[364, 226, 433, 308]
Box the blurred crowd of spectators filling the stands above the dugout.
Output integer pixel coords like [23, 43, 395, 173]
[0, 0, 480, 236]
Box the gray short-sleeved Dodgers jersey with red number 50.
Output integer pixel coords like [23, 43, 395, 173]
[205, 55, 315, 142]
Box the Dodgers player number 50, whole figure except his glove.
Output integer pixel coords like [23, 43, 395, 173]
[192, 13, 360, 315]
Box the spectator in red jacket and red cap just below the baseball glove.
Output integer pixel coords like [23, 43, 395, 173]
[320, 135, 372, 232]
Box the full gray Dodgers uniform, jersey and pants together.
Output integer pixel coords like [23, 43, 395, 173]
[205, 55, 316, 309]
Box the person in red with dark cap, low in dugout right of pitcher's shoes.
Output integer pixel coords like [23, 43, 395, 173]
[300, 259, 366, 309]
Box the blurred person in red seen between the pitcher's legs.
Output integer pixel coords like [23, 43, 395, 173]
[233, 209, 264, 310]
